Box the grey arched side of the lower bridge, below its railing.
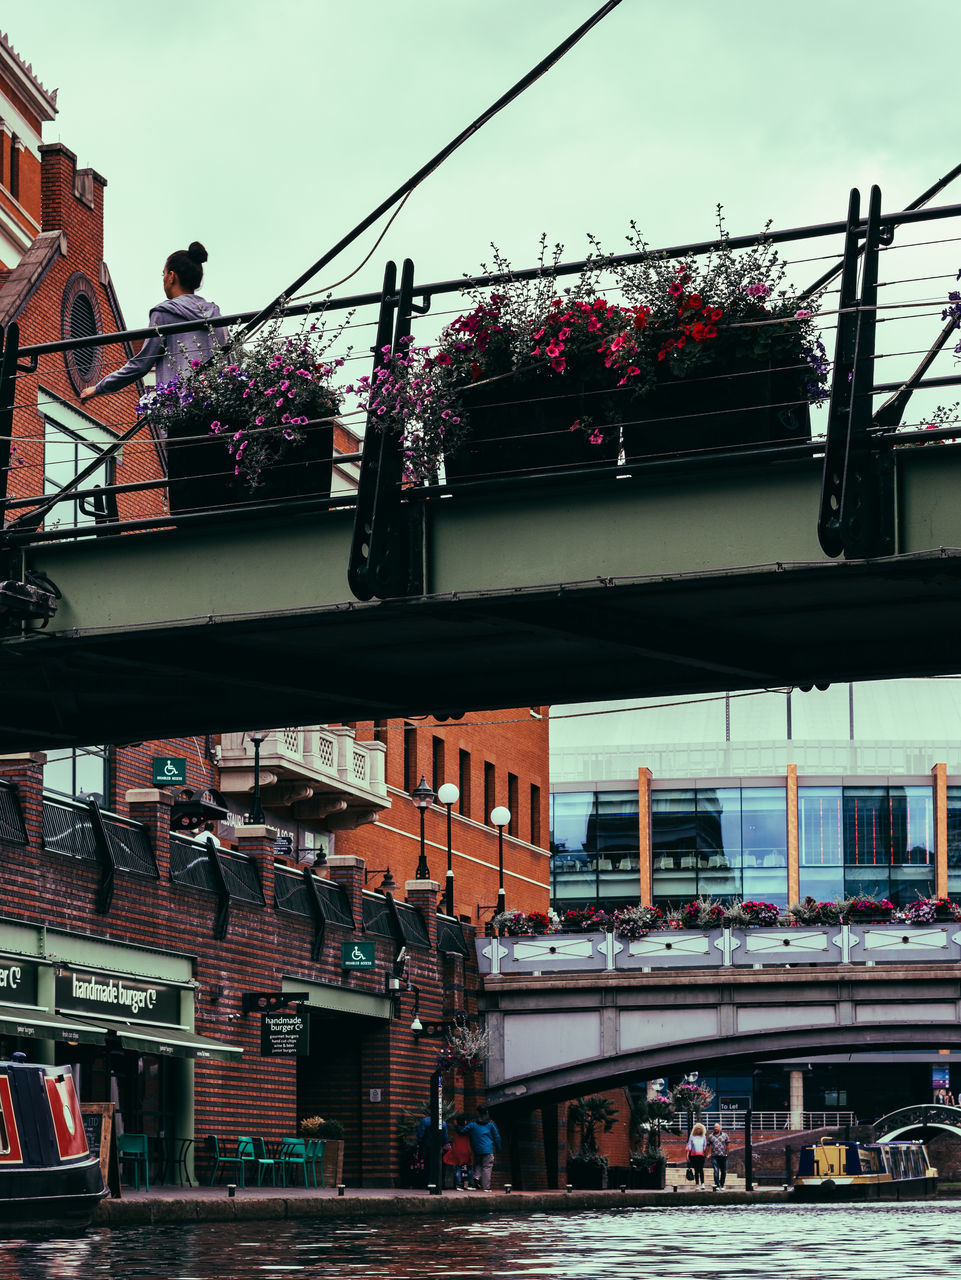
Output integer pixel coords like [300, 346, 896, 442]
[484, 964, 961, 1123]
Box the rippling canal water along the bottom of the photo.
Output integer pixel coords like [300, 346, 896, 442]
[0, 1202, 961, 1280]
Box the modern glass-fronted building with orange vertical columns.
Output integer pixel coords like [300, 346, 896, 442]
[552, 680, 961, 910]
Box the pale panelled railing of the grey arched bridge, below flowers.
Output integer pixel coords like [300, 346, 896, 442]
[476, 920, 961, 975]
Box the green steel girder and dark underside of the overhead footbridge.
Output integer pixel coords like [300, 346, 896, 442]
[0, 447, 961, 753]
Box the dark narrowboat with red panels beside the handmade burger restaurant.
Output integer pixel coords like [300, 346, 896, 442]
[0, 1053, 106, 1235]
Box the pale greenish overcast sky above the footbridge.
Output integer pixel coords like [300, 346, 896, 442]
[3, 0, 961, 747]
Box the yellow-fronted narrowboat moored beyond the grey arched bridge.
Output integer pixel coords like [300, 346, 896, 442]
[795, 1138, 938, 1199]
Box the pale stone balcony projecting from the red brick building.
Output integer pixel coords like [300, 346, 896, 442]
[220, 724, 390, 831]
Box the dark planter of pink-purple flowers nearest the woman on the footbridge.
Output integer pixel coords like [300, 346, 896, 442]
[146, 308, 343, 512]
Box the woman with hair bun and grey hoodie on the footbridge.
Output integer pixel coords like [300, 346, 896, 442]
[81, 241, 228, 401]
